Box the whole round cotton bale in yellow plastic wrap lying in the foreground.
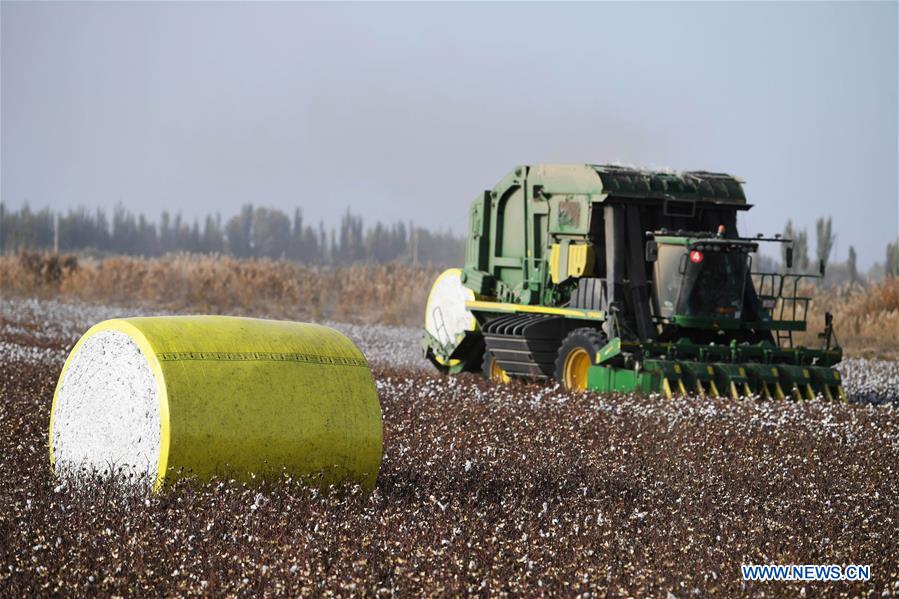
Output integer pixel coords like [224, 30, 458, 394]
[50, 316, 383, 489]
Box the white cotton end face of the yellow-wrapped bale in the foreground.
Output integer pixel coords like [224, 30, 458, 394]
[50, 331, 161, 483]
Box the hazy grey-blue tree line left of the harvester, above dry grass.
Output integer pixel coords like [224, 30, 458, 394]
[0, 203, 465, 265]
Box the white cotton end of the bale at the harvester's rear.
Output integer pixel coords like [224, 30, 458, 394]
[425, 268, 478, 364]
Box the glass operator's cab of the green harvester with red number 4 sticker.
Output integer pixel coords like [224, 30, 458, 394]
[655, 243, 749, 318]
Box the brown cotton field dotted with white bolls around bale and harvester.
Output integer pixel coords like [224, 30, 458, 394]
[0, 299, 899, 598]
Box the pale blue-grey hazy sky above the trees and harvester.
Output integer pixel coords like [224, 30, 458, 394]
[0, 1, 899, 266]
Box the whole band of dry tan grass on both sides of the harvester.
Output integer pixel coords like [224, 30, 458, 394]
[0, 254, 899, 359]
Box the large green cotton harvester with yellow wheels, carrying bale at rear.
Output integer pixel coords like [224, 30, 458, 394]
[422, 165, 845, 401]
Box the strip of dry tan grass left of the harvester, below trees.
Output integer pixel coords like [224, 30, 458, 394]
[0, 254, 437, 325]
